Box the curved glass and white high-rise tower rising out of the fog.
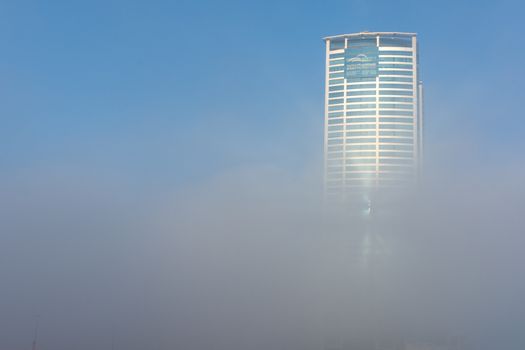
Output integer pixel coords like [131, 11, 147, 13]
[324, 32, 423, 199]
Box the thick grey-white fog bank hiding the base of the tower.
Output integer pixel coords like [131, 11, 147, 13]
[0, 157, 525, 350]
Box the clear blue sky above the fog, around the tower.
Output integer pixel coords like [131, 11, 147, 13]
[0, 0, 525, 187]
